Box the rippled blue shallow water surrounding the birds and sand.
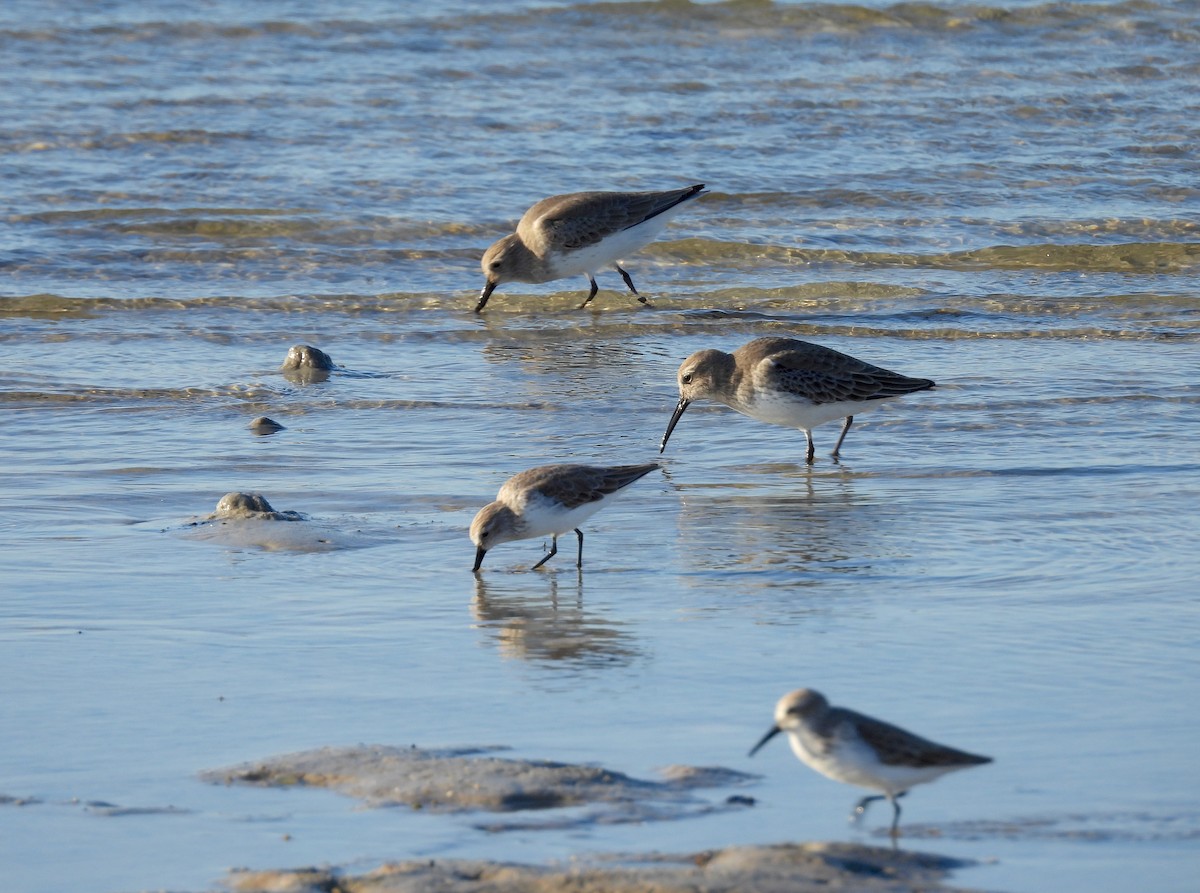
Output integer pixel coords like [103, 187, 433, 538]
[0, 0, 1200, 893]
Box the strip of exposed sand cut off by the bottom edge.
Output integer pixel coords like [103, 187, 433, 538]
[227, 843, 967, 893]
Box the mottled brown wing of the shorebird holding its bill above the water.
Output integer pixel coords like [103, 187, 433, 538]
[755, 342, 934, 403]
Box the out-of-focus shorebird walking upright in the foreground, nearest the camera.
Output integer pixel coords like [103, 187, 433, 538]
[750, 689, 991, 837]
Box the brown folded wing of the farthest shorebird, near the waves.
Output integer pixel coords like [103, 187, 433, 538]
[517, 186, 698, 253]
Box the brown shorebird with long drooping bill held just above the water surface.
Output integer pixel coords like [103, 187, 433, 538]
[659, 337, 934, 465]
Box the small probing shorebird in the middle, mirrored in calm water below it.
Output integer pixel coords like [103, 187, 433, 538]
[470, 462, 659, 571]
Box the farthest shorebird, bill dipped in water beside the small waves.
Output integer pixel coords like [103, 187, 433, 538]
[475, 184, 704, 313]
